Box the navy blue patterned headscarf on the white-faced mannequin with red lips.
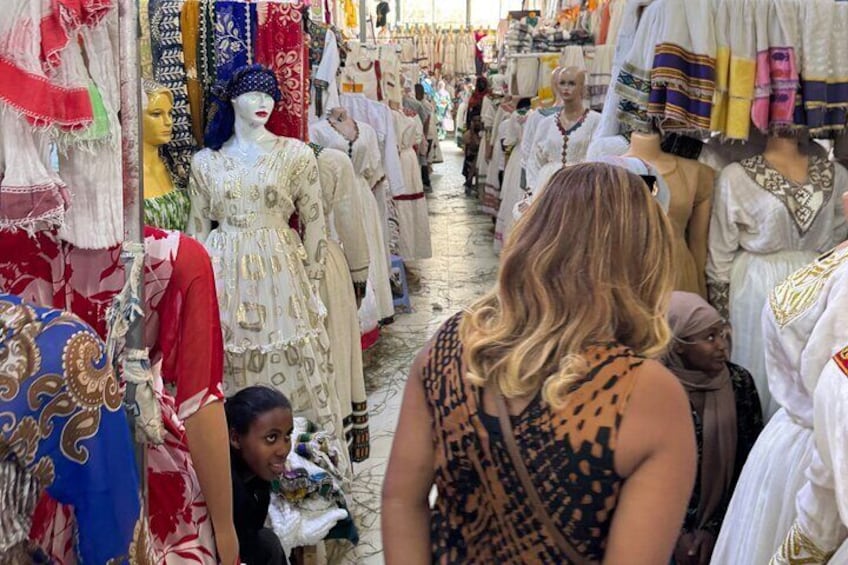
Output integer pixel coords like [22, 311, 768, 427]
[203, 65, 282, 151]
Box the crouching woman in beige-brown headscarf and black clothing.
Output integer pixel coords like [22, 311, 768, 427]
[664, 292, 763, 565]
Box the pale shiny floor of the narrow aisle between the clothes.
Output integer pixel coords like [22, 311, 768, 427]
[338, 141, 498, 565]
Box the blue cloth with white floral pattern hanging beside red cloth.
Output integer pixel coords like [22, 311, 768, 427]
[213, 0, 256, 80]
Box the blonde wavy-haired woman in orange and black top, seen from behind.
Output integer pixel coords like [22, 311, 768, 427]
[382, 163, 696, 565]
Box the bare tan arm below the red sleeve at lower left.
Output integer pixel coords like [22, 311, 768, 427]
[185, 402, 239, 565]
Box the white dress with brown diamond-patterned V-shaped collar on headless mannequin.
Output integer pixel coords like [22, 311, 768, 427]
[706, 155, 848, 419]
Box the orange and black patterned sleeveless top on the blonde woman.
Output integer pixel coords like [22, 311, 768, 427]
[422, 314, 644, 563]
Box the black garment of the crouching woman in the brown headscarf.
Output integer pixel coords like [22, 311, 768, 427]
[683, 363, 763, 539]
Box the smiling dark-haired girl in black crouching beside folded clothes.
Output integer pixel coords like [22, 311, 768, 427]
[226, 386, 293, 565]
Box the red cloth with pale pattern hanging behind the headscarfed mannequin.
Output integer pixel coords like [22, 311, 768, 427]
[256, 0, 309, 141]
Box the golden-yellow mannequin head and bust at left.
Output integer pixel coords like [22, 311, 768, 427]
[142, 80, 190, 231]
